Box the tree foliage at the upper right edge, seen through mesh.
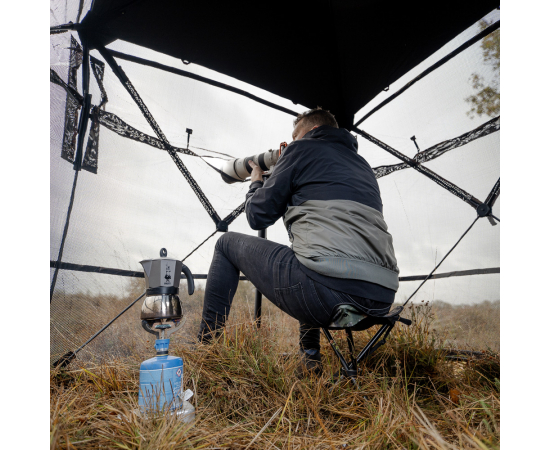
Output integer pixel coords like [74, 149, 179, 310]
[465, 20, 500, 119]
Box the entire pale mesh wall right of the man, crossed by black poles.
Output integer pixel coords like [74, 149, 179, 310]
[356, 12, 500, 312]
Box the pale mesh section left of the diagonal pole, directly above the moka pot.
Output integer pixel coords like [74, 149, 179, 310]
[51, 125, 224, 270]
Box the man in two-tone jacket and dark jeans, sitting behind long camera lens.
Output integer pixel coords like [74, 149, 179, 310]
[199, 108, 399, 373]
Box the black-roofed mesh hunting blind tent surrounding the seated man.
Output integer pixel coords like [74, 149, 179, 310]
[50, 0, 500, 361]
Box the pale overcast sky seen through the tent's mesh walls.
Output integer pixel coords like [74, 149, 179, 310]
[50, 7, 500, 303]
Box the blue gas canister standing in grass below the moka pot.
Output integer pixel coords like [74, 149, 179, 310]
[139, 339, 183, 412]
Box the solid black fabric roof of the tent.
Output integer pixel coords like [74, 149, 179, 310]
[80, 0, 499, 129]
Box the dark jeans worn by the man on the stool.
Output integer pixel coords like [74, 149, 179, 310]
[199, 232, 391, 350]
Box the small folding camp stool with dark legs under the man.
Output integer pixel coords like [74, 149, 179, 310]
[321, 305, 412, 386]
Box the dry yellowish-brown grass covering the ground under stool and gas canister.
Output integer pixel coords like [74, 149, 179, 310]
[50, 283, 500, 449]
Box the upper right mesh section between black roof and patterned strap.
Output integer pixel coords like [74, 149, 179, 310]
[355, 10, 500, 137]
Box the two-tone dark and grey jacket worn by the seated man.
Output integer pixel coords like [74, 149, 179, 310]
[245, 126, 399, 291]
